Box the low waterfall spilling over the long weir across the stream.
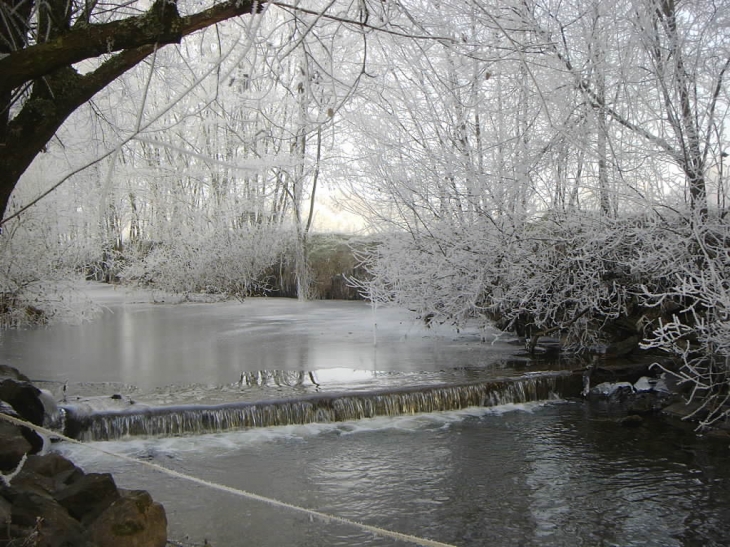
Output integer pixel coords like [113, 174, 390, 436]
[65, 373, 580, 441]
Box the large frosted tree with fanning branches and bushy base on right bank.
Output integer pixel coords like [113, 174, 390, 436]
[349, 0, 730, 349]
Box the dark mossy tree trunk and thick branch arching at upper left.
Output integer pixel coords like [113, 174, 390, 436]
[0, 0, 261, 222]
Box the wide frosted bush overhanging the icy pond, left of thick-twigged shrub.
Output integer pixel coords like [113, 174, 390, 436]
[358, 215, 644, 350]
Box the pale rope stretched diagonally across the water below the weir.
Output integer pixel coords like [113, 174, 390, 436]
[0, 414, 456, 547]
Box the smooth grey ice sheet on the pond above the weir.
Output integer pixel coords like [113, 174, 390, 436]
[0, 292, 515, 391]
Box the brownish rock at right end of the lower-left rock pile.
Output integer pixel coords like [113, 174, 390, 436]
[89, 490, 167, 547]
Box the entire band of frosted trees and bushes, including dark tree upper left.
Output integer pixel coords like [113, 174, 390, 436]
[0, 0, 730, 428]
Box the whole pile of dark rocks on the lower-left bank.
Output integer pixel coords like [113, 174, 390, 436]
[0, 365, 167, 547]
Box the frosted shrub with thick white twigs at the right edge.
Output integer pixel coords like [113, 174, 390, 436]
[641, 218, 730, 427]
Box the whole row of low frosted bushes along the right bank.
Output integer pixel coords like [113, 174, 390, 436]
[361, 213, 730, 423]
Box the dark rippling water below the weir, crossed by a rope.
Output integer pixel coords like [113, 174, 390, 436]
[57, 403, 730, 547]
